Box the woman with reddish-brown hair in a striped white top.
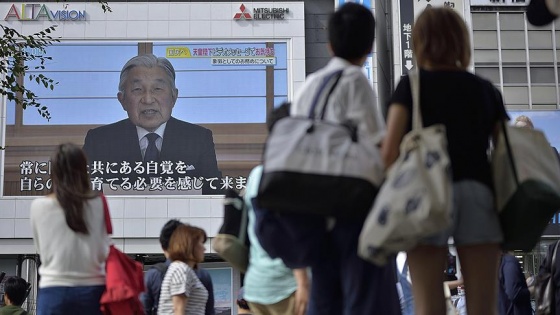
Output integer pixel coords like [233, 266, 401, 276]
[158, 225, 208, 315]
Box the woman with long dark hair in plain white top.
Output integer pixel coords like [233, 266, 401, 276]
[30, 143, 110, 315]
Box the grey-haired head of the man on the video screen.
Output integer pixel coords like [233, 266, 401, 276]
[117, 54, 178, 131]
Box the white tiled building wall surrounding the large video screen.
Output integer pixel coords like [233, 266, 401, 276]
[0, 1, 305, 254]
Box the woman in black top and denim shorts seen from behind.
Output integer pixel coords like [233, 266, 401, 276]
[382, 8, 507, 315]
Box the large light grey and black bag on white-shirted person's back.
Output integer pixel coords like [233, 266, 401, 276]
[255, 70, 383, 221]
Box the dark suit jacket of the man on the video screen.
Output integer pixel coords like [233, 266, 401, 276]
[83, 117, 222, 194]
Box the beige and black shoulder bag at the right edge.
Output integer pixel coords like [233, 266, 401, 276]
[492, 112, 560, 251]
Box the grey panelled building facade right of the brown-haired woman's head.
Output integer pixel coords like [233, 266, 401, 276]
[471, 7, 560, 110]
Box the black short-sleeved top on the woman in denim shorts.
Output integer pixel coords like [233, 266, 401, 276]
[390, 70, 507, 188]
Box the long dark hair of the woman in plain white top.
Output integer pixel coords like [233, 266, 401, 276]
[51, 143, 95, 234]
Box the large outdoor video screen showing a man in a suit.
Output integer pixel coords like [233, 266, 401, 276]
[3, 41, 289, 196]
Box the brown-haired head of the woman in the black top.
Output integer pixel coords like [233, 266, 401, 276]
[412, 7, 471, 70]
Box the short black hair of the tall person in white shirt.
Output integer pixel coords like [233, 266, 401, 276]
[328, 2, 375, 60]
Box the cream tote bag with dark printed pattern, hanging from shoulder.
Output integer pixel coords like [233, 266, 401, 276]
[359, 71, 452, 265]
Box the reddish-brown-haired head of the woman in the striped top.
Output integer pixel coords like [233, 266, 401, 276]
[167, 224, 207, 266]
